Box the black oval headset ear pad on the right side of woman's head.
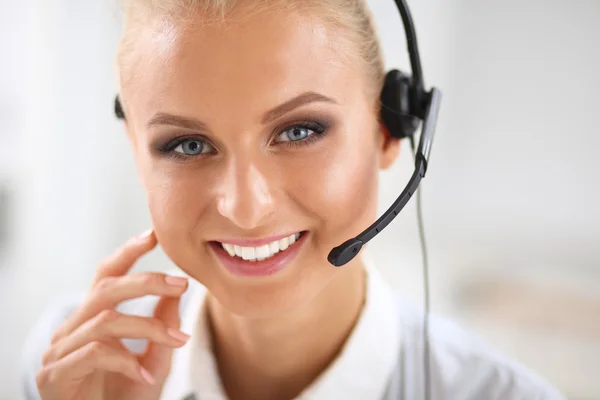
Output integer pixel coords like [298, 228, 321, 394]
[381, 69, 420, 139]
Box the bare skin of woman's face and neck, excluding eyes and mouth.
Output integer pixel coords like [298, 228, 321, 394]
[121, 3, 399, 400]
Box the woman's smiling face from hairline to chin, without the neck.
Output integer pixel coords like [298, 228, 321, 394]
[122, 6, 398, 316]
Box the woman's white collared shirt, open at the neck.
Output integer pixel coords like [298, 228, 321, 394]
[23, 260, 565, 400]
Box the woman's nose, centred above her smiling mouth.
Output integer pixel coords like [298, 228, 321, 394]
[217, 158, 275, 230]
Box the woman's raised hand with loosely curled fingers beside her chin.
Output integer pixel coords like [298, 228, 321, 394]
[36, 231, 189, 400]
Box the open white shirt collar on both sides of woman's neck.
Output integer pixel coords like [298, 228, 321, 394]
[163, 258, 401, 400]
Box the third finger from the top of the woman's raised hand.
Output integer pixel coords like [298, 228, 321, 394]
[42, 310, 186, 363]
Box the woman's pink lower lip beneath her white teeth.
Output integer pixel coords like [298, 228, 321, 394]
[209, 232, 309, 277]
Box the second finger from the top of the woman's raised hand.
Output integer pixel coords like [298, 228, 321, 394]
[51, 272, 188, 344]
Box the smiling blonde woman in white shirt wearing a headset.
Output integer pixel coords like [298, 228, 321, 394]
[26, 0, 562, 400]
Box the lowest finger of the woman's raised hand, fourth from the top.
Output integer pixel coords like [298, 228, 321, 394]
[36, 342, 151, 393]
